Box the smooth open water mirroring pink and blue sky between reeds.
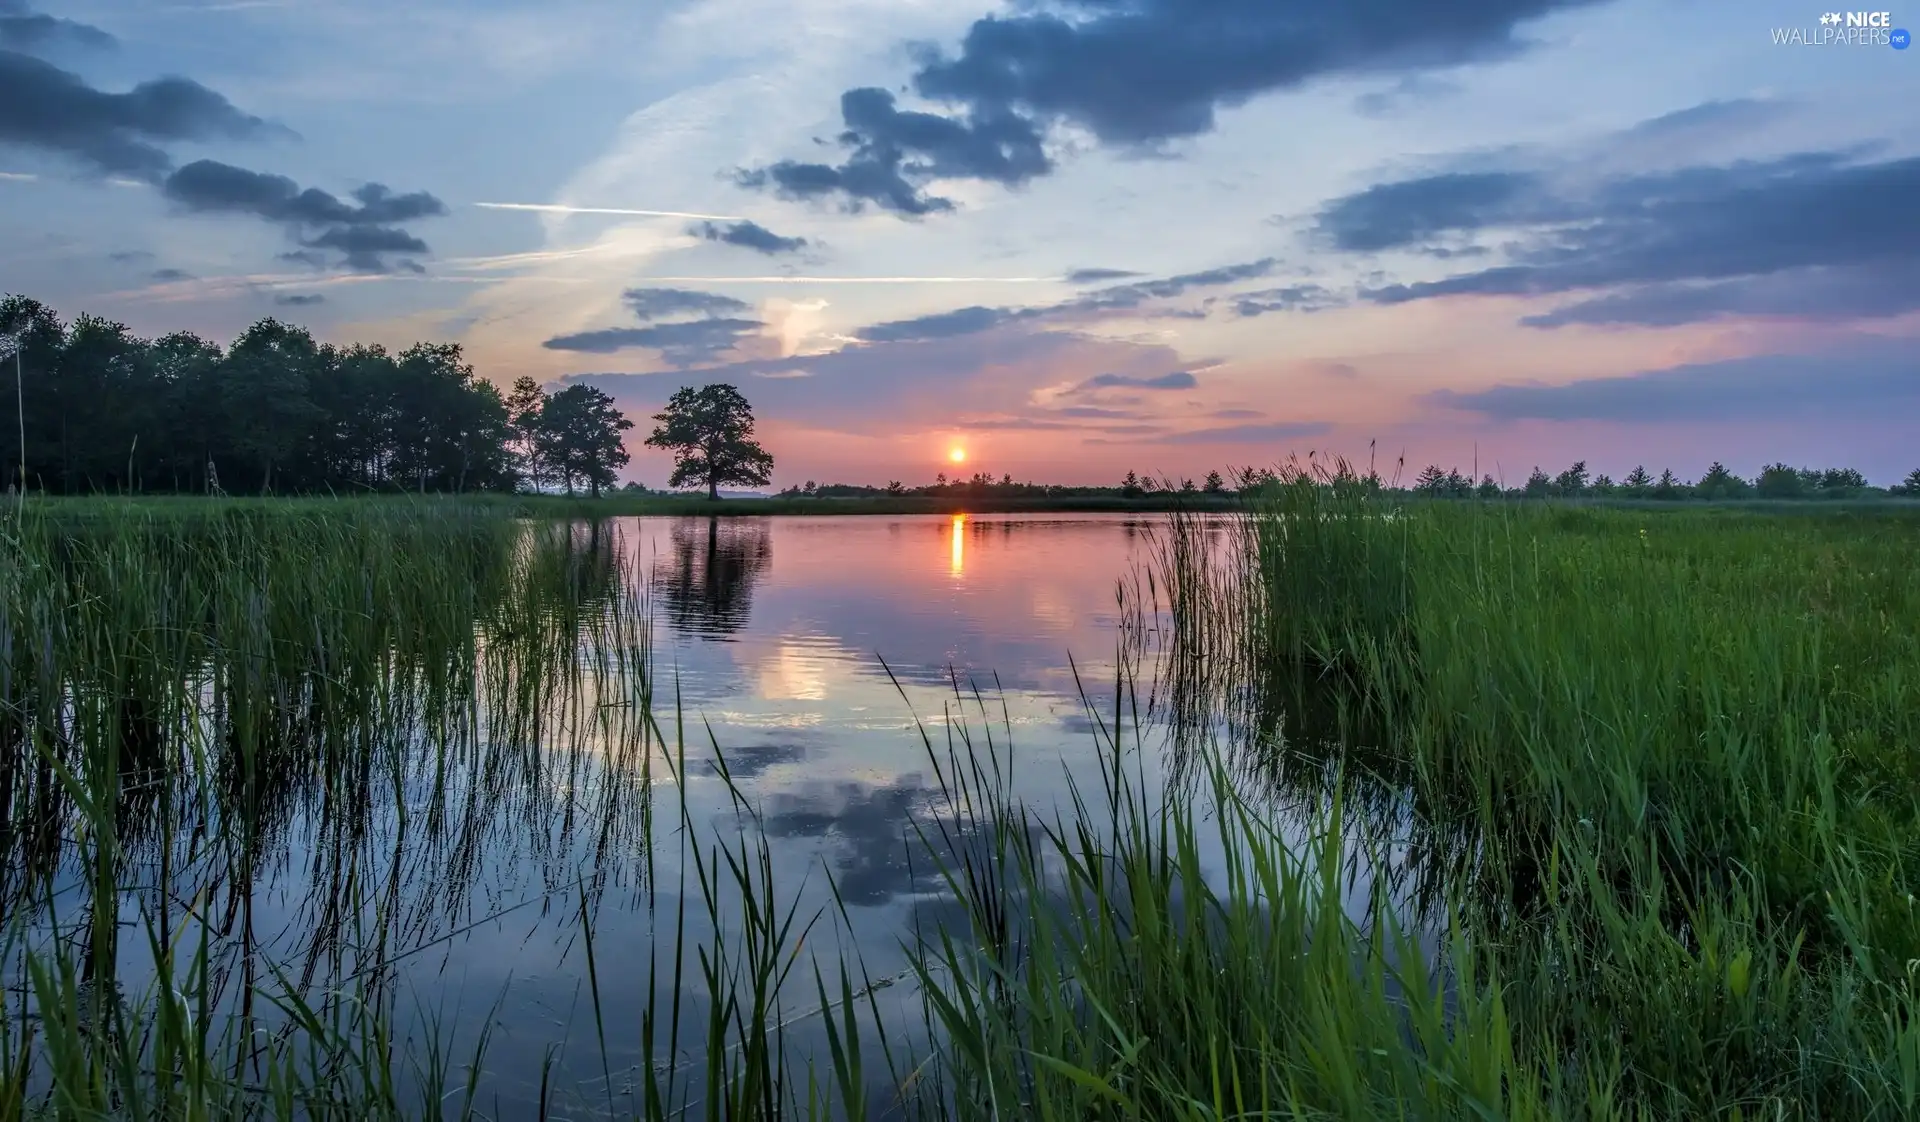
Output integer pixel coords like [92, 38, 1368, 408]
[30, 515, 1420, 1116]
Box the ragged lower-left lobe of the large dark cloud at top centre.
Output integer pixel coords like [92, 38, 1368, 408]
[737, 86, 1052, 215]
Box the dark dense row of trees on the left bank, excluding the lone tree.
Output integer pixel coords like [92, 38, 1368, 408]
[0, 296, 632, 494]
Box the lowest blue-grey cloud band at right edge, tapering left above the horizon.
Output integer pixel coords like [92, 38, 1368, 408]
[1427, 340, 1920, 423]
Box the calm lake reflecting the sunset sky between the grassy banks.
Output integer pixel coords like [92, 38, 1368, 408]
[3, 515, 1428, 1116]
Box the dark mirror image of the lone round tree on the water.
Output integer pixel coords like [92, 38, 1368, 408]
[653, 519, 774, 638]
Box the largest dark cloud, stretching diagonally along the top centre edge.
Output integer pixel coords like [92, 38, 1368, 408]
[741, 0, 1596, 215]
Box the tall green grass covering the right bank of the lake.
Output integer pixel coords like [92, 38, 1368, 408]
[1121, 473, 1920, 1118]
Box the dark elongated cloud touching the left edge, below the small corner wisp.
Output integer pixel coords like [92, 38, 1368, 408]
[0, 50, 271, 181]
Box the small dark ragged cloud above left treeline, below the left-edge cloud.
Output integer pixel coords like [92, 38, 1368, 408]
[161, 159, 447, 273]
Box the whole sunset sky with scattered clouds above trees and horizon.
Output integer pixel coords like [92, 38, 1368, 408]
[0, 0, 1920, 486]
